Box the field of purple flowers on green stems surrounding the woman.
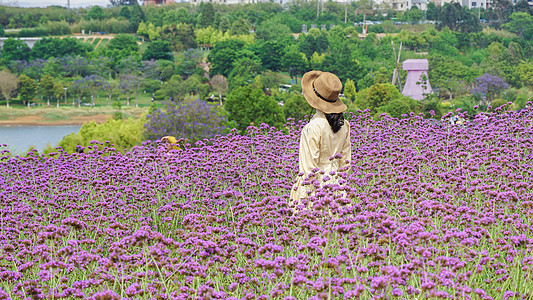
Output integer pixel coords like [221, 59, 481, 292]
[0, 112, 533, 299]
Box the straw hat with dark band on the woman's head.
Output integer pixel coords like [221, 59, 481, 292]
[302, 71, 347, 114]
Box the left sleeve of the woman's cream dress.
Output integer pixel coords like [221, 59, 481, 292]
[299, 126, 320, 178]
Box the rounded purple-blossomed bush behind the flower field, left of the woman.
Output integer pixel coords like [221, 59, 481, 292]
[144, 99, 227, 143]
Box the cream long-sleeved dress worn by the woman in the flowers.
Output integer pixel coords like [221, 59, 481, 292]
[290, 110, 352, 205]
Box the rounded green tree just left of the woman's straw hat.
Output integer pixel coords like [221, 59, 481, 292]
[225, 85, 285, 132]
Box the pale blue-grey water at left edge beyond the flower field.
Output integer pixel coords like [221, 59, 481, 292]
[0, 125, 81, 155]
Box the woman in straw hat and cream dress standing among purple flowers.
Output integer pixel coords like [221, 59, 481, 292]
[291, 71, 352, 207]
